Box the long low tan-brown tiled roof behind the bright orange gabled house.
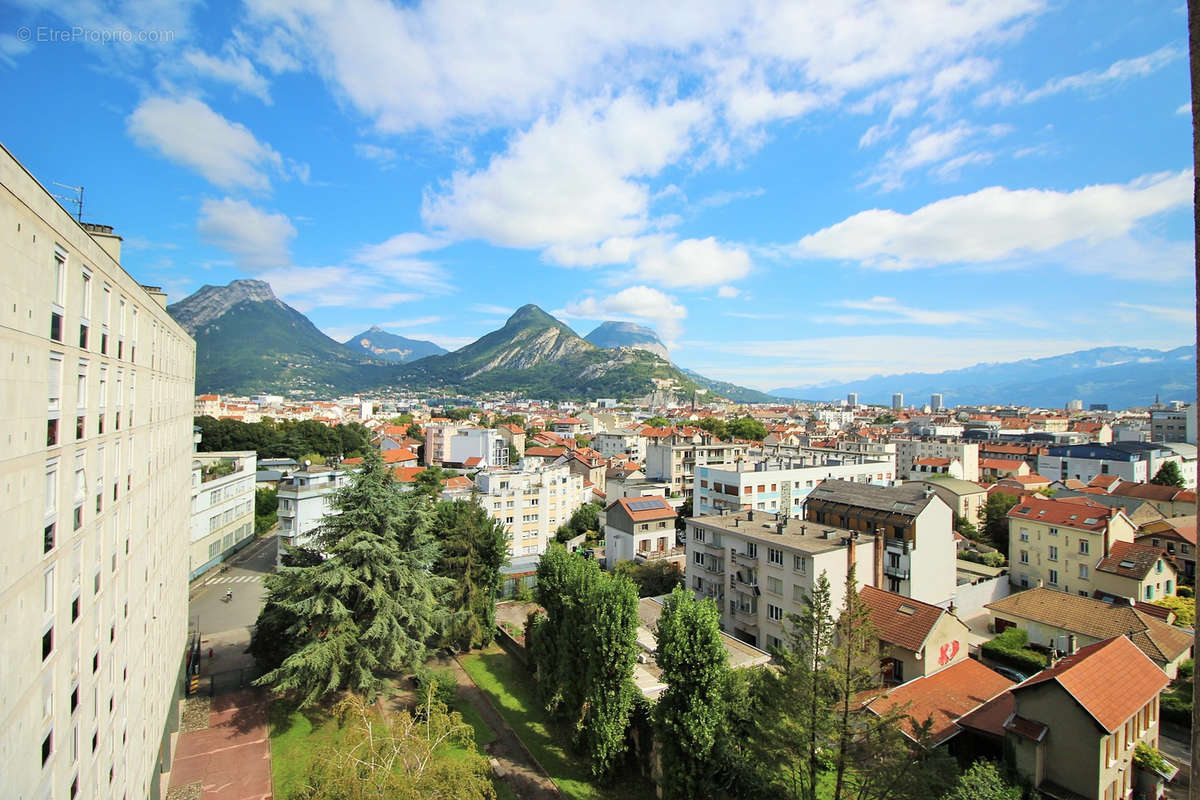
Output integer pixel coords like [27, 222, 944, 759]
[984, 587, 1192, 664]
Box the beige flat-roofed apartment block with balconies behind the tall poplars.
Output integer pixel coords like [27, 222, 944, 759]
[686, 509, 883, 649]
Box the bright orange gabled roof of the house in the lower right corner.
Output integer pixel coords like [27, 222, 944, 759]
[1013, 636, 1170, 733]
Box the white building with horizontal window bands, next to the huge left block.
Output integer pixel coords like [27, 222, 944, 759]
[187, 450, 258, 579]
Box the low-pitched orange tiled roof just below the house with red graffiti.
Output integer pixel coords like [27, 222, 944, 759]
[866, 658, 1013, 745]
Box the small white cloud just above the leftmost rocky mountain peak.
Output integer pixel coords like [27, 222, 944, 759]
[196, 197, 296, 272]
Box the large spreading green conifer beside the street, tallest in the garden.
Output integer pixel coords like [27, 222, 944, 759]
[256, 450, 449, 705]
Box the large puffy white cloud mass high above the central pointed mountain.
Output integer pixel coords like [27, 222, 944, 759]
[421, 94, 706, 248]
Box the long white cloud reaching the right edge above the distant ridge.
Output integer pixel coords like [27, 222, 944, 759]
[796, 172, 1192, 271]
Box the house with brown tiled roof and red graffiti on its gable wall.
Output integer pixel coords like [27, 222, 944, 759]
[858, 587, 969, 686]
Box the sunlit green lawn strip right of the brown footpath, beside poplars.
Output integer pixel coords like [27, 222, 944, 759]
[460, 644, 654, 800]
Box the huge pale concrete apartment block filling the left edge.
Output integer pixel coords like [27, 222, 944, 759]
[0, 143, 196, 800]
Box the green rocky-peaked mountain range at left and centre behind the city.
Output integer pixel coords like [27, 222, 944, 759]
[167, 279, 766, 401]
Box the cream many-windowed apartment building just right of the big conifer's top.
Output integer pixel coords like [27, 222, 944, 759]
[475, 459, 592, 559]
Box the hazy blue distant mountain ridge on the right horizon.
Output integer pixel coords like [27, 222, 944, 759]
[772, 344, 1196, 408]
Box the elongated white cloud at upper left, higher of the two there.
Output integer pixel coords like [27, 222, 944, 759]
[126, 97, 283, 191]
